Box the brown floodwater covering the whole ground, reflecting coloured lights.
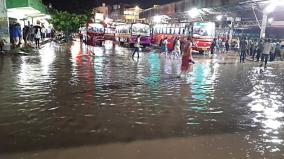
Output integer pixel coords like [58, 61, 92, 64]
[0, 42, 284, 159]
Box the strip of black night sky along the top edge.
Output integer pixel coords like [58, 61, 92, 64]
[42, 0, 177, 12]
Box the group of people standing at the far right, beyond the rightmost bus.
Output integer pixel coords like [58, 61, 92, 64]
[240, 37, 283, 68]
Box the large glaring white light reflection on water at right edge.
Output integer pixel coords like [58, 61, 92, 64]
[248, 68, 284, 149]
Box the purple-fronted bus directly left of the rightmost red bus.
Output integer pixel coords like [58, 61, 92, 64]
[115, 23, 151, 47]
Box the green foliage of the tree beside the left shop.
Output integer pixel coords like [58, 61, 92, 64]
[49, 11, 89, 34]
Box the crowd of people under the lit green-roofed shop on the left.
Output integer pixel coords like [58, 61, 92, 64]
[9, 21, 55, 49]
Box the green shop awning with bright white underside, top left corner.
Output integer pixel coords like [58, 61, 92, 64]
[6, 0, 48, 19]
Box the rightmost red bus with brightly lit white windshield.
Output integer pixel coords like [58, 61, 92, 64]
[152, 22, 215, 53]
